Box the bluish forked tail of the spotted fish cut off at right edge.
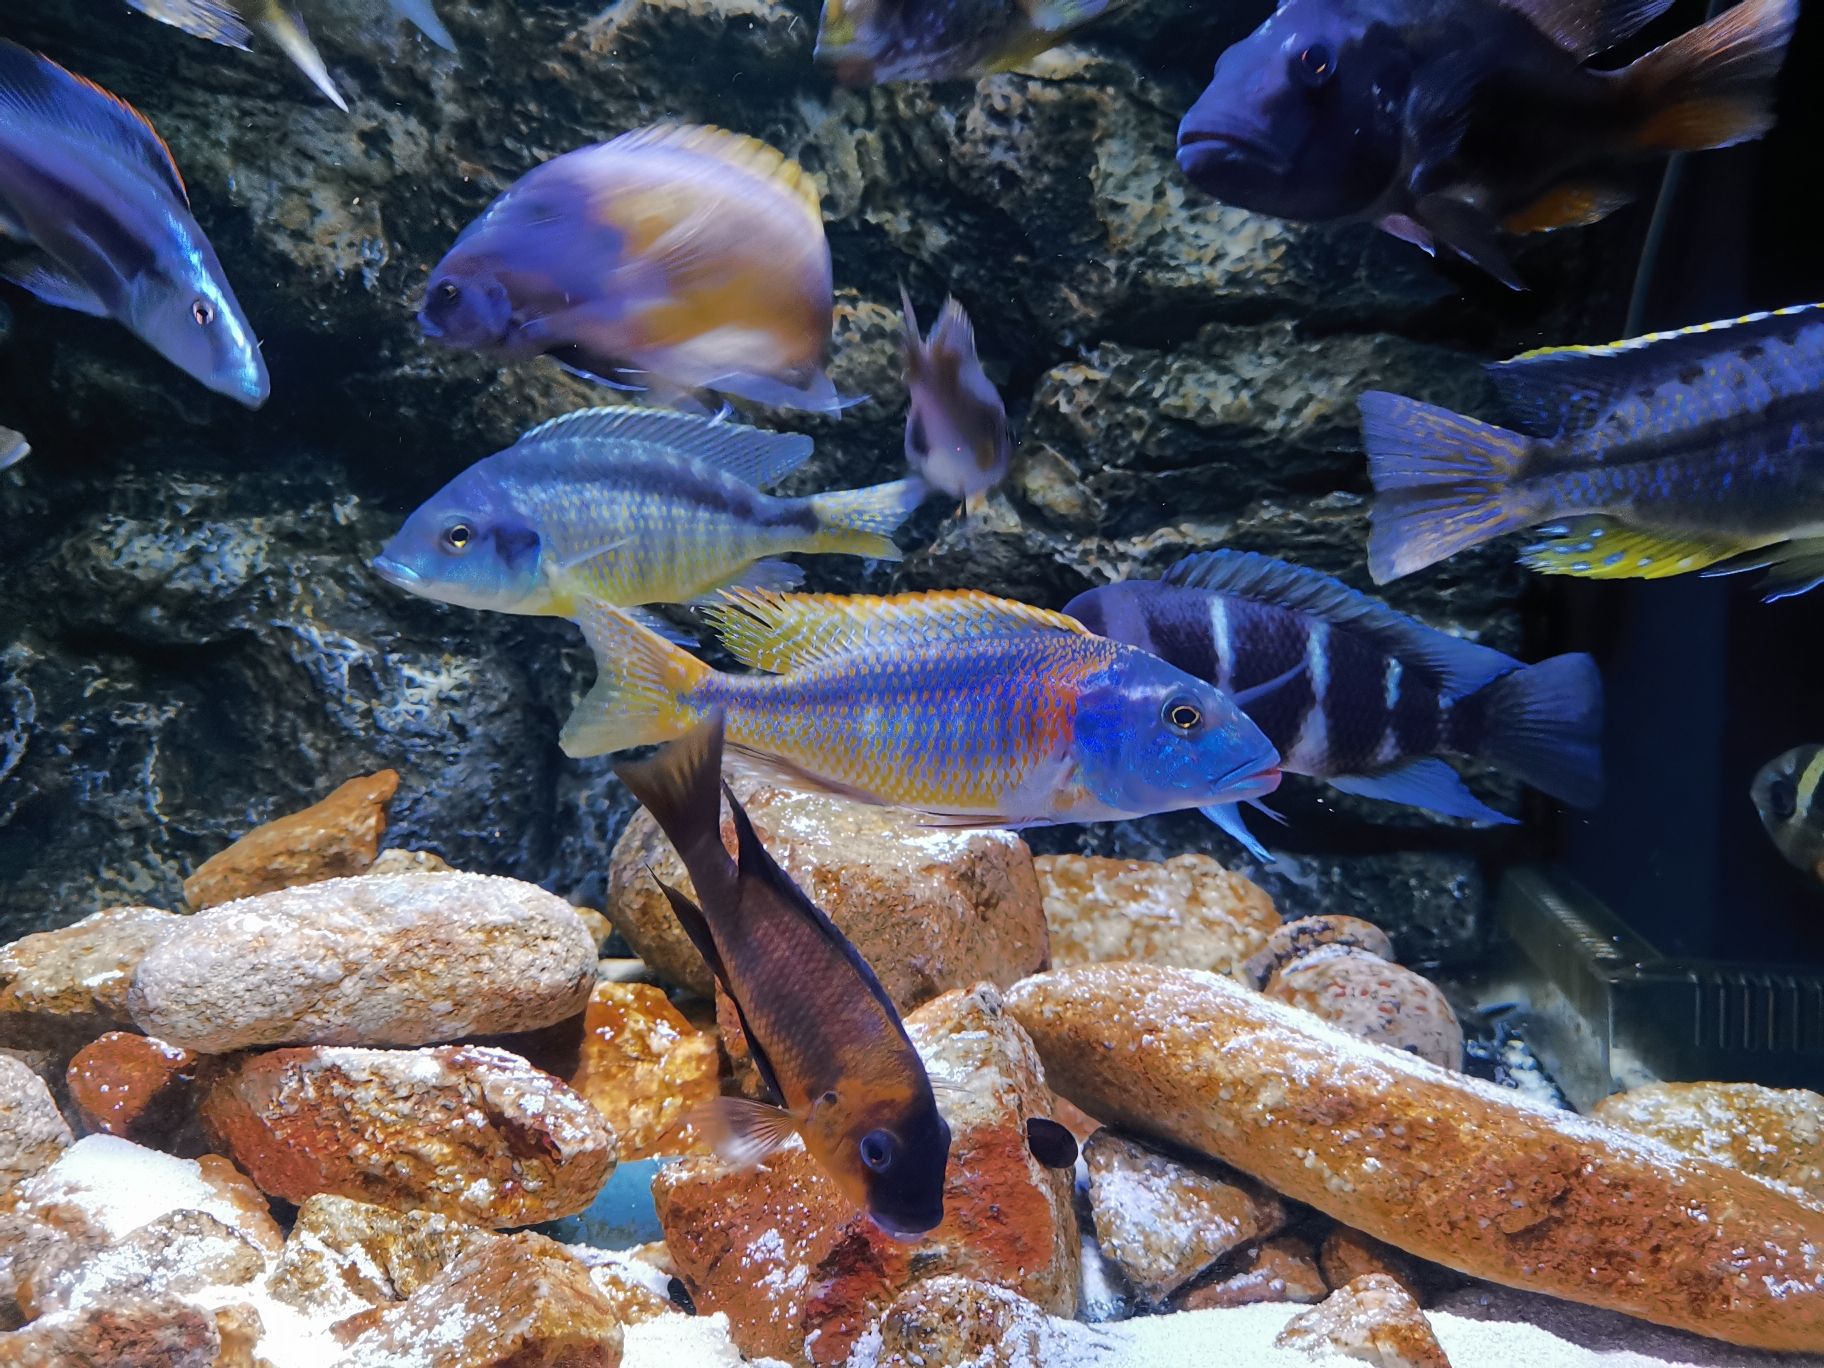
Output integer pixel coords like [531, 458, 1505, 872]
[1361, 390, 1529, 584]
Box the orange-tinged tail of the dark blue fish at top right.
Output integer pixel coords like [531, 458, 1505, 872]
[1622, 0, 1798, 151]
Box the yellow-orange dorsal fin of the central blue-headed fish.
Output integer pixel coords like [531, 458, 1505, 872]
[704, 589, 1089, 675]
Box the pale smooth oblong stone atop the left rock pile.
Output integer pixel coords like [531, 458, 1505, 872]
[128, 874, 595, 1054]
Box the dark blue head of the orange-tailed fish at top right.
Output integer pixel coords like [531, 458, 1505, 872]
[1178, 0, 1412, 219]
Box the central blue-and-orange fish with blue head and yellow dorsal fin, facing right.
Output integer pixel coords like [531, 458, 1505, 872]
[560, 591, 1279, 828]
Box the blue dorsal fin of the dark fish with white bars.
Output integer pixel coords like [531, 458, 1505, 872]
[1162, 551, 1519, 695]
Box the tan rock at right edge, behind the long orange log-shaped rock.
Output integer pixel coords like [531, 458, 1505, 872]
[1594, 1083, 1824, 1202]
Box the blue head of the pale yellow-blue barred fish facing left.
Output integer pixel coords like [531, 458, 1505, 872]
[374, 461, 545, 613]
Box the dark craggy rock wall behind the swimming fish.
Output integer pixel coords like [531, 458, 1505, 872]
[0, 0, 1638, 961]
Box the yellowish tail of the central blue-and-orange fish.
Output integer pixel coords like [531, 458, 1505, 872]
[558, 604, 711, 755]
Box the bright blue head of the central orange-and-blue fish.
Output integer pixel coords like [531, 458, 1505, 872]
[1076, 648, 1279, 815]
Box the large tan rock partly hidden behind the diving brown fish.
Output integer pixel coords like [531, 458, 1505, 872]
[604, 781, 1047, 1012]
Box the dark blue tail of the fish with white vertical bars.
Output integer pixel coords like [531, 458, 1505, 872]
[1465, 655, 1601, 808]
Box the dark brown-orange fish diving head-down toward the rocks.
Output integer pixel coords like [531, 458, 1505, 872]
[615, 711, 950, 1240]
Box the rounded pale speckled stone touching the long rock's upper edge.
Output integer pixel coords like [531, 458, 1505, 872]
[1264, 945, 1463, 1069]
